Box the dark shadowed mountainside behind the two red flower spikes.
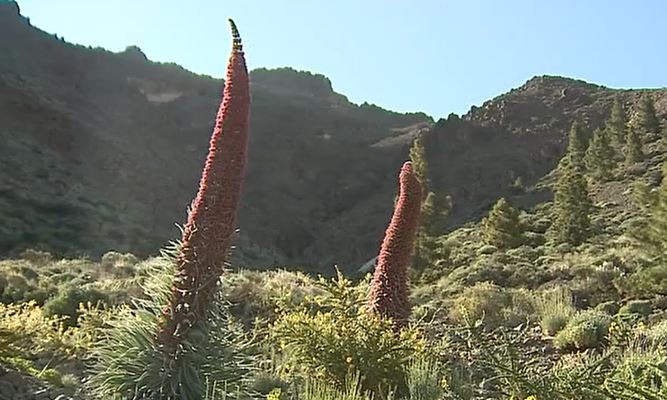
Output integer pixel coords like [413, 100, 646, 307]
[0, 3, 431, 272]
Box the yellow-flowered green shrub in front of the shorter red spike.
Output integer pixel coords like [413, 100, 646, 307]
[270, 274, 425, 394]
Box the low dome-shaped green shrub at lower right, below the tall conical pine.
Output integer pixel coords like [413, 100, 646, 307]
[554, 310, 611, 350]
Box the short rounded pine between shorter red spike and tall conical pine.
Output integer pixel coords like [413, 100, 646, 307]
[482, 198, 522, 249]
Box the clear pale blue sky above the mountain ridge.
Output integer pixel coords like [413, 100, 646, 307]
[18, 0, 667, 119]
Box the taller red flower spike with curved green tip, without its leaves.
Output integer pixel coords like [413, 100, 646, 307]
[158, 19, 250, 351]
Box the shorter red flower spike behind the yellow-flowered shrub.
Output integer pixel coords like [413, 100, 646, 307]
[367, 162, 422, 328]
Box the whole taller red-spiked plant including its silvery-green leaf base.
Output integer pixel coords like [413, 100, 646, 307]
[87, 20, 256, 400]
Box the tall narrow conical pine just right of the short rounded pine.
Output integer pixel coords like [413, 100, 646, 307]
[551, 122, 593, 246]
